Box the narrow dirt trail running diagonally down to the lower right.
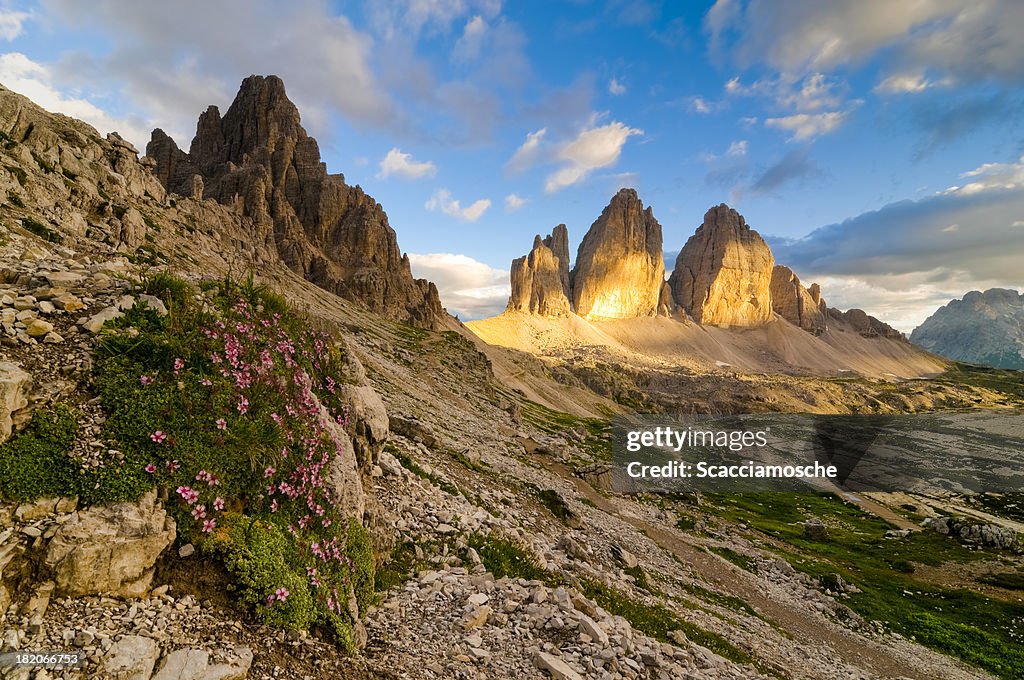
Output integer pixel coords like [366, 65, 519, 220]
[534, 456, 988, 680]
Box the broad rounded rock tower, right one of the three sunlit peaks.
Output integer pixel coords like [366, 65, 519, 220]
[669, 204, 775, 327]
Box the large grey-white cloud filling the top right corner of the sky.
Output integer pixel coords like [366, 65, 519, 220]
[705, 0, 1024, 82]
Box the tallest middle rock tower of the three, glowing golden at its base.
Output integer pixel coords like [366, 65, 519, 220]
[570, 188, 665, 320]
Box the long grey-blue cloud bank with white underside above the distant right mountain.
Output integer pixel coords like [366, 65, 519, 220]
[769, 154, 1024, 331]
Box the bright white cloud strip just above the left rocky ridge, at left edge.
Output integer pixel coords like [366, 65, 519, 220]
[0, 52, 152, 150]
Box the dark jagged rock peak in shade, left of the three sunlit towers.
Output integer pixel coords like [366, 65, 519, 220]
[146, 76, 444, 328]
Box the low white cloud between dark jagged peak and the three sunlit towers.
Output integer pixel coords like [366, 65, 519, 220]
[409, 253, 512, 320]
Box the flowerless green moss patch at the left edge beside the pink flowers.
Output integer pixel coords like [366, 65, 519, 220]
[0, 405, 80, 501]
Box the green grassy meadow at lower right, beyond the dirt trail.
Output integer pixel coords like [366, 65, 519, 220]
[706, 494, 1024, 678]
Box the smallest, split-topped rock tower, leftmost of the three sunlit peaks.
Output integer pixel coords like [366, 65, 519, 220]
[508, 224, 570, 316]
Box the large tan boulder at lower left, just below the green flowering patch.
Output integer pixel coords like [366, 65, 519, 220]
[45, 490, 175, 597]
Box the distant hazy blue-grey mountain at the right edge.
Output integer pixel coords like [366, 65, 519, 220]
[910, 288, 1024, 369]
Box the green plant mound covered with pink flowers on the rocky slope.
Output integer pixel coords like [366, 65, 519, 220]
[86, 273, 374, 648]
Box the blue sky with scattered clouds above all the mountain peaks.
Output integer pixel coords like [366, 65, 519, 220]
[0, 0, 1024, 332]
